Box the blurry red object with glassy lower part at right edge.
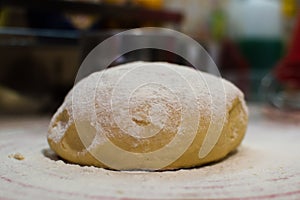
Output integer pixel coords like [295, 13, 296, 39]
[262, 15, 300, 121]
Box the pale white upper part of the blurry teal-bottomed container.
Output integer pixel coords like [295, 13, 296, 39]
[227, 0, 283, 38]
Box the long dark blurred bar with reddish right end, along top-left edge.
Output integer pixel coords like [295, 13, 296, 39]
[0, 0, 183, 24]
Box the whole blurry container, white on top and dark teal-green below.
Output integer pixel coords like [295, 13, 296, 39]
[228, 0, 283, 100]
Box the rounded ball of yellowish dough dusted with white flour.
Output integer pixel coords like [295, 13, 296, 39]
[48, 62, 248, 170]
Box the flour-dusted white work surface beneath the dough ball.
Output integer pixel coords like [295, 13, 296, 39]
[0, 106, 300, 200]
